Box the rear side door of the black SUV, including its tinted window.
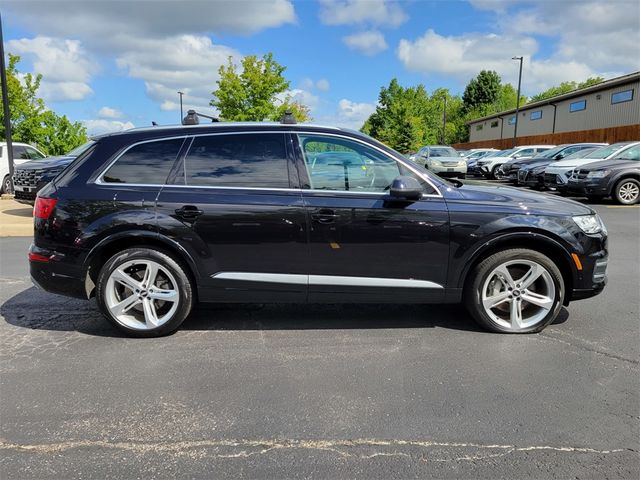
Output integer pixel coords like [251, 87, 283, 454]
[156, 131, 307, 302]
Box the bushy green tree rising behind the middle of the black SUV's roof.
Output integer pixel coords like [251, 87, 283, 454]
[210, 53, 310, 122]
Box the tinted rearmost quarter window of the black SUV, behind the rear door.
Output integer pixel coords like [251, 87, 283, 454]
[102, 138, 184, 185]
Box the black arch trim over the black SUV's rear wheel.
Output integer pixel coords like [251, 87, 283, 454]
[84, 231, 198, 298]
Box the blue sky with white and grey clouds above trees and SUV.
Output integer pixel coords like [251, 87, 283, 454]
[2, 0, 640, 134]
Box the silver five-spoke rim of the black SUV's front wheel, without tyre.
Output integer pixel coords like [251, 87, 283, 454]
[481, 260, 556, 332]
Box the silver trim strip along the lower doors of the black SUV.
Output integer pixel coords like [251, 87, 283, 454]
[211, 272, 444, 290]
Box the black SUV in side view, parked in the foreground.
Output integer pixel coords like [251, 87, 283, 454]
[29, 123, 607, 337]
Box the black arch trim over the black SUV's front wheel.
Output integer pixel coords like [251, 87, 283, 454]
[458, 232, 577, 305]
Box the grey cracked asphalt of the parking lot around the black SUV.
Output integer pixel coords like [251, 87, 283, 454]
[0, 197, 640, 479]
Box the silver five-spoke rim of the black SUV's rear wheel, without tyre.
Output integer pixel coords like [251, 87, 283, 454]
[104, 260, 180, 330]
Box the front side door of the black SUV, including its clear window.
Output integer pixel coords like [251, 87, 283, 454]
[295, 133, 449, 302]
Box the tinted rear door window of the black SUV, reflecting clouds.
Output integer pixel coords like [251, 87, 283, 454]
[177, 133, 289, 188]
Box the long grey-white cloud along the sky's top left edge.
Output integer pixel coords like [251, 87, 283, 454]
[4, 0, 296, 39]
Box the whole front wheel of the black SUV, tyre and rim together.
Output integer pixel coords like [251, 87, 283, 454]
[463, 248, 564, 333]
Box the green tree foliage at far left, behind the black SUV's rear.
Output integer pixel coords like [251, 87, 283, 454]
[0, 54, 87, 155]
